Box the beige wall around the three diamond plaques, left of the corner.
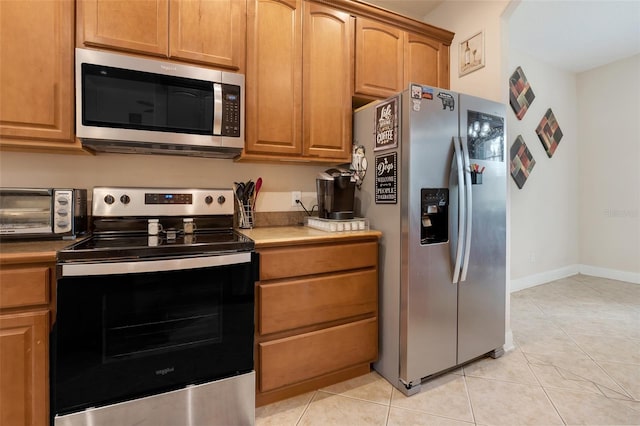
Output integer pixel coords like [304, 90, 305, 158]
[507, 51, 581, 290]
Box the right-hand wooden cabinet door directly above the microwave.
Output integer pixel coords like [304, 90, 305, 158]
[169, 0, 246, 70]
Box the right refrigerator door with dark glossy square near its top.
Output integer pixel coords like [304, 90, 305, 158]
[457, 95, 507, 364]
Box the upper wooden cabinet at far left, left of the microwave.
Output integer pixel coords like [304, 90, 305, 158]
[0, 0, 79, 149]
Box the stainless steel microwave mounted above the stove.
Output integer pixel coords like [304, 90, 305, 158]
[75, 49, 244, 158]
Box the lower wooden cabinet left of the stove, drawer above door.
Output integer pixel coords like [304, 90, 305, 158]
[0, 265, 51, 426]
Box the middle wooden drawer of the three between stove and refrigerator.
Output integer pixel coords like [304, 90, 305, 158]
[258, 269, 378, 334]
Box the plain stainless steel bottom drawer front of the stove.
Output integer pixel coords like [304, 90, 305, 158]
[55, 372, 255, 426]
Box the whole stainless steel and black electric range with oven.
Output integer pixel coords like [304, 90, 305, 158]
[51, 187, 258, 426]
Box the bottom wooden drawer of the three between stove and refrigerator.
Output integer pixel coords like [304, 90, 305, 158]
[258, 318, 378, 392]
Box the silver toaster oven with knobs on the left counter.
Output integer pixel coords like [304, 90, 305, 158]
[0, 188, 88, 239]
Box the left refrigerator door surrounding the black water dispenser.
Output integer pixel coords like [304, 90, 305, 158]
[400, 87, 458, 385]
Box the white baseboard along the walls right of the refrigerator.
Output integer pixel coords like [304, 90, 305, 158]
[510, 264, 640, 293]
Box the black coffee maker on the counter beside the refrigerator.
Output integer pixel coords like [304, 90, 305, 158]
[316, 168, 356, 220]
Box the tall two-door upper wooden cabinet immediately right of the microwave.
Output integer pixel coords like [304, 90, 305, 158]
[242, 0, 353, 163]
